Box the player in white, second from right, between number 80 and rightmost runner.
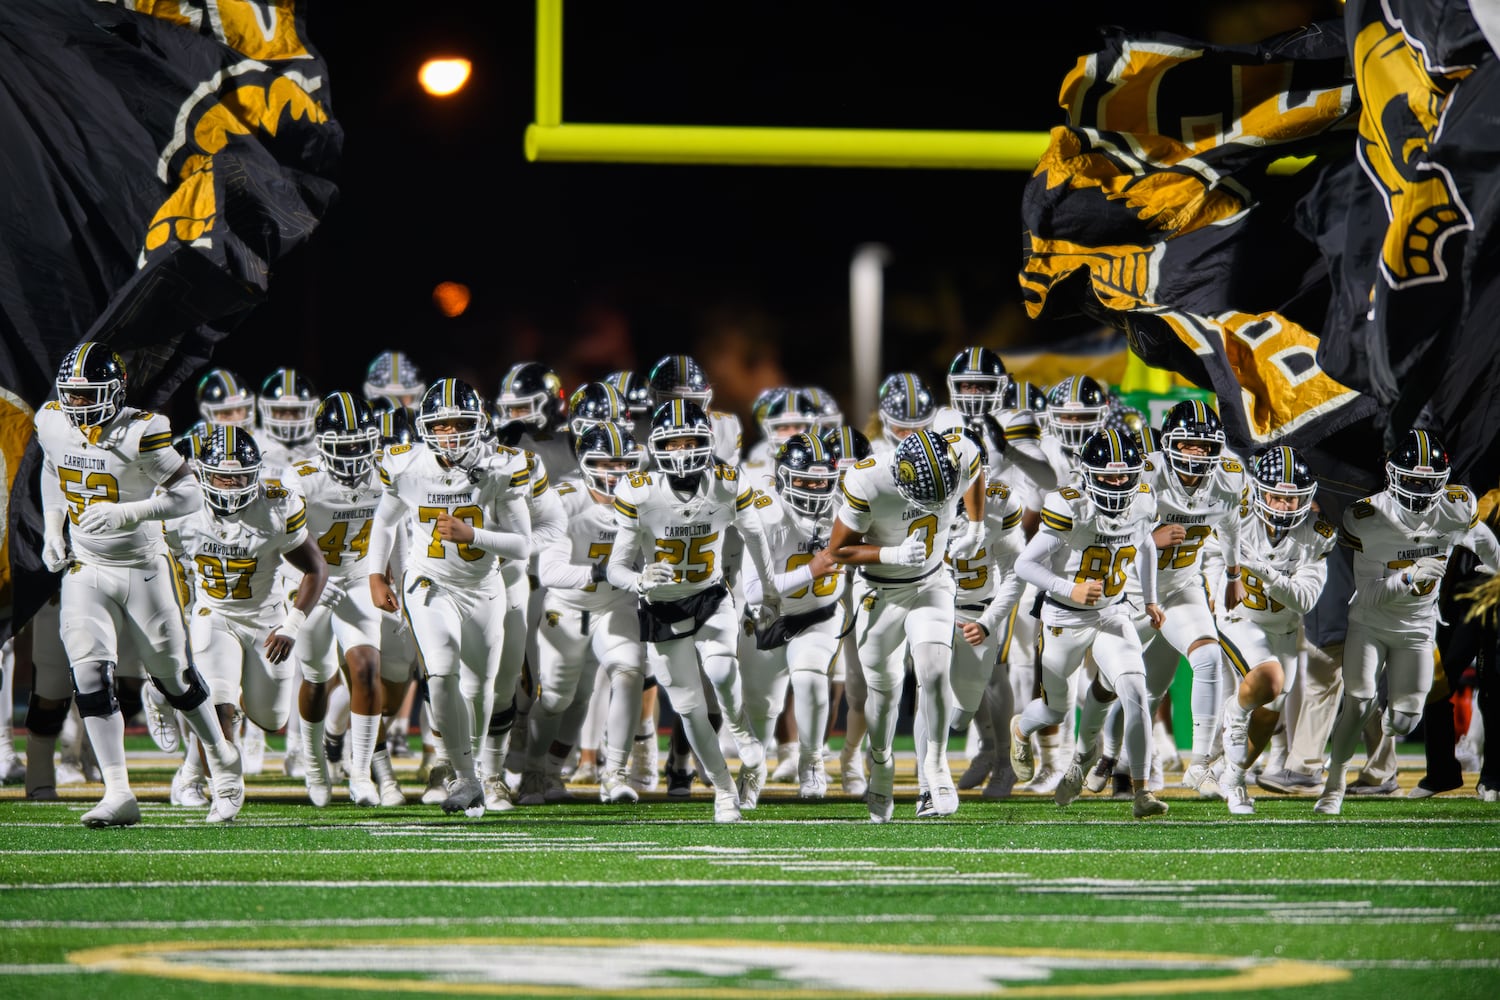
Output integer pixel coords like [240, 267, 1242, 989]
[1218, 447, 1338, 816]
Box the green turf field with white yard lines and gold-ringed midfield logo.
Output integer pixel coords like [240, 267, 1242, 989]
[0, 754, 1500, 1000]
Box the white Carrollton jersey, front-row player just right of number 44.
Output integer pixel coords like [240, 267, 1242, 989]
[380, 444, 531, 588]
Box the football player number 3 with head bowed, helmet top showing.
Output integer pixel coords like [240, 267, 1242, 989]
[828, 425, 984, 823]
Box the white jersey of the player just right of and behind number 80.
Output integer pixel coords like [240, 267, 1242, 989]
[1140, 451, 1250, 595]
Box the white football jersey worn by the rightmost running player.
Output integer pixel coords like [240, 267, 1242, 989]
[1340, 486, 1496, 630]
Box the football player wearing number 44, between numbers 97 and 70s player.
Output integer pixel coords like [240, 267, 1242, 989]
[290, 393, 408, 807]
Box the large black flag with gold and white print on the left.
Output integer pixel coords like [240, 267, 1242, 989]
[0, 0, 342, 637]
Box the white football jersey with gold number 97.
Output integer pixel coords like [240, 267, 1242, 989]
[167, 483, 308, 622]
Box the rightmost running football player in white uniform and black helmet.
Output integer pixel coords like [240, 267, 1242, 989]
[1313, 430, 1500, 816]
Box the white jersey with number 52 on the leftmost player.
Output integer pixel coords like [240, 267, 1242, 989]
[36, 402, 183, 567]
